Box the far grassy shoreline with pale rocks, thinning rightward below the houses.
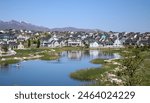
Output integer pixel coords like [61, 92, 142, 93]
[0, 47, 122, 64]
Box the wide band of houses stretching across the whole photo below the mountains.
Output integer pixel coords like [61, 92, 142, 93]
[0, 31, 150, 52]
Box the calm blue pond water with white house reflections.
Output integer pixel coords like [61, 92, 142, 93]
[0, 50, 115, 86]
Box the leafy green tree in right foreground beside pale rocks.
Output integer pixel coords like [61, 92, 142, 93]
[118, 48, 144, 86]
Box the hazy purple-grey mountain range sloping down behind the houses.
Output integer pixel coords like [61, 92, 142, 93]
[0, 20, 102, 32]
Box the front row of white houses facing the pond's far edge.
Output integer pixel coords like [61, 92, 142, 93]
[41, 34, 127, 48]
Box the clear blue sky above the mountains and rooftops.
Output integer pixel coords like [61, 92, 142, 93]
[0, 0, 150, 32]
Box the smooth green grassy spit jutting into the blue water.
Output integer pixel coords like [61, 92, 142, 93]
[70, 59, 117, 81]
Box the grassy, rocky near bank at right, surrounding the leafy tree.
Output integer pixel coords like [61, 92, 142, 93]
[70, 47, 150, 86]
